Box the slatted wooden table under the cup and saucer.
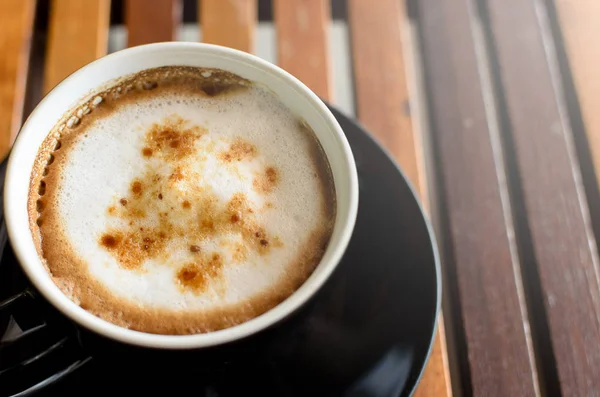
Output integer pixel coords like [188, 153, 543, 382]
[0, 0, 600, 397]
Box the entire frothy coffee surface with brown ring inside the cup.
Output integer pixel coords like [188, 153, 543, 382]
[28, 66, 335, 334]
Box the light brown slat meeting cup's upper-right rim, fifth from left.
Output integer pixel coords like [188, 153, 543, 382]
[273, 0, 332, 100]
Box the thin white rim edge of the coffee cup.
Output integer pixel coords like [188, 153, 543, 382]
[4, 42, 358, 350]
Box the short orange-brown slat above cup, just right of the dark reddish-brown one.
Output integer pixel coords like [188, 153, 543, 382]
[198, 0, 257, 53]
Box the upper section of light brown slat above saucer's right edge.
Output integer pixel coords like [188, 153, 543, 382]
[348, 0, 419, 178]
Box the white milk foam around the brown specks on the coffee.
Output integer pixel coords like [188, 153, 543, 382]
[47, 87, 325, 311]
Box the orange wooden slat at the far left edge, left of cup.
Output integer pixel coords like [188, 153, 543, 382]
[0, 0, 35, 158]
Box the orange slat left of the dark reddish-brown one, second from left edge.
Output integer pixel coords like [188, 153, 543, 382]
[44, 0, 110, 92]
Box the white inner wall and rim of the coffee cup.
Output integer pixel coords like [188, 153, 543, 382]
[4, 43, 358, 349]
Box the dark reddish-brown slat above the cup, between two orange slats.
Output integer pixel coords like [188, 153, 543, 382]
[125, 0, 183, 47]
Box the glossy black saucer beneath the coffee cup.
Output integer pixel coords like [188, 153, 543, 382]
[0, 109, 440, 397]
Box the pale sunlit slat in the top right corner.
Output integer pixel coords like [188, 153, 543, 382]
[555, 0, 600, 178]
